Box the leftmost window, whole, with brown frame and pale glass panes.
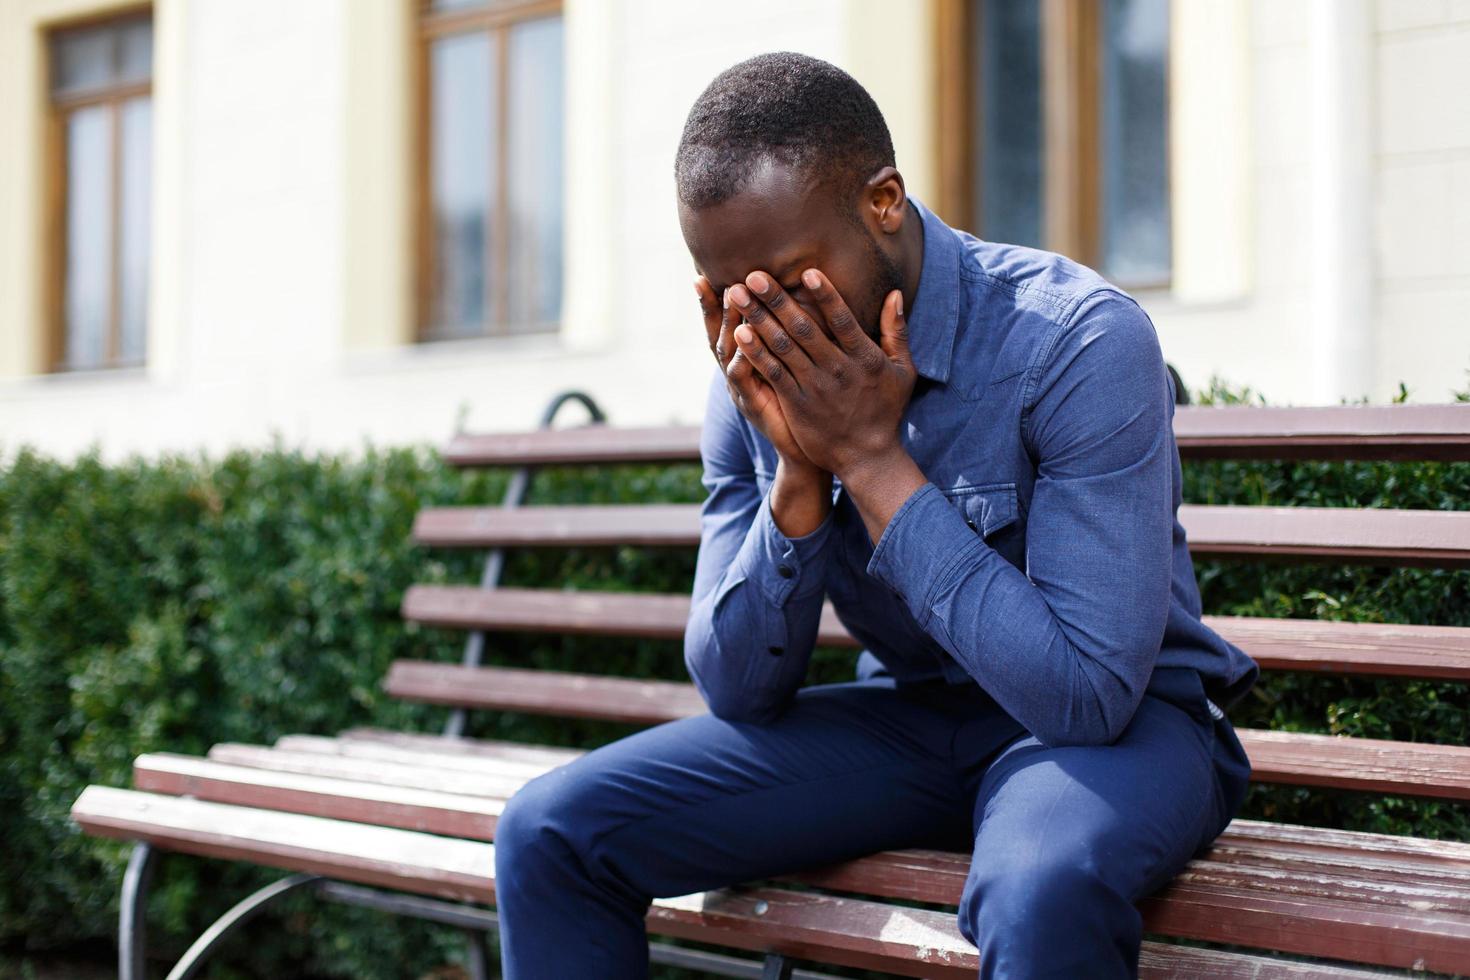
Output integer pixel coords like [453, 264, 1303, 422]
[49, 13, 153, 370]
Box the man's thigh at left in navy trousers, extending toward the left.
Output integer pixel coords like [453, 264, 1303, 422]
[507, 679, 1005, 898]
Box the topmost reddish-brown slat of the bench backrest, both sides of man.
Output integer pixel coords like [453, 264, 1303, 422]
[445, 404, 1470, 466]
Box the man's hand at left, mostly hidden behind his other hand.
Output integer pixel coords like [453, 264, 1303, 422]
[694, 276, 832, 538]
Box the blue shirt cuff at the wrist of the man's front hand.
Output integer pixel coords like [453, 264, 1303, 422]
[867, 483, 986, 626]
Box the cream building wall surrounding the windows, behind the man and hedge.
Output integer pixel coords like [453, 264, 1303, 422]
[0, 0, 1470, 457]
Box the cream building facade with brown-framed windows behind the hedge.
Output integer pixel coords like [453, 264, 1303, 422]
[0, 0, 1470, 458]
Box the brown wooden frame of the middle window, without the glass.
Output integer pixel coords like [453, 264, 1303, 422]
[420, 0, 563, 342]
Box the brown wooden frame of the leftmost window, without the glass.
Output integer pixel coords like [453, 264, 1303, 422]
[41, 3, 153, 373]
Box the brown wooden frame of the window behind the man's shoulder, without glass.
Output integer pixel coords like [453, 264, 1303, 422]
[935, 0, 1173, 289]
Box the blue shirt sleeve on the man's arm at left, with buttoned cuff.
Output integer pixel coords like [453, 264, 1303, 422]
[684, 364, 832, 724]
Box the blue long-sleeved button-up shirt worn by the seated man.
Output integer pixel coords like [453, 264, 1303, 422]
[684, 197, 1258, 745]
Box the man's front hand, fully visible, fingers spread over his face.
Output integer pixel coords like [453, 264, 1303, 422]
[728, 269, 925, 541]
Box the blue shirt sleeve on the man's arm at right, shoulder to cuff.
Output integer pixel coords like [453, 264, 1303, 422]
[867, 291, 1177, 745]
